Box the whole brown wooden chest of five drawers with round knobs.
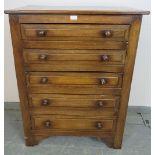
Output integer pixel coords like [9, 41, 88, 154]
[5, 6, 149, 148]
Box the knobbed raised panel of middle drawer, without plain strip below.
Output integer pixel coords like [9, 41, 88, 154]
[28, 72, 122, 87]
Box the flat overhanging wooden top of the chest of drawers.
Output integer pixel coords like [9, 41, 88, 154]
[5, 6, 150, 15]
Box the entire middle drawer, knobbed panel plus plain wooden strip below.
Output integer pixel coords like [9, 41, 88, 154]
[27, 72, 122, 95]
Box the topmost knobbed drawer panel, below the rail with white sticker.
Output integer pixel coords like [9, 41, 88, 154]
[21, 24, 129, 40]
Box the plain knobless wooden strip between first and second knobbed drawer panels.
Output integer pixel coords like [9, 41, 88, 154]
[23, 40, 128, 50]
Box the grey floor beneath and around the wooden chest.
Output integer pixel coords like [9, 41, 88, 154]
[4, 103, 151, 155]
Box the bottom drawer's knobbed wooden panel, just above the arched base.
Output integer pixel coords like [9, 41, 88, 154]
[32, 115, 115, 131]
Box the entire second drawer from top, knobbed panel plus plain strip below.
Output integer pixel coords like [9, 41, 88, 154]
[23, 49, 126, 72]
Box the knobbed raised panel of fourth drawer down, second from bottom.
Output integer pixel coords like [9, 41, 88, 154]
[29, 94, 119, 110]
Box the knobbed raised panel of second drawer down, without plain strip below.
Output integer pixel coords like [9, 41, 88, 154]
[23, 49, 126, 65]
